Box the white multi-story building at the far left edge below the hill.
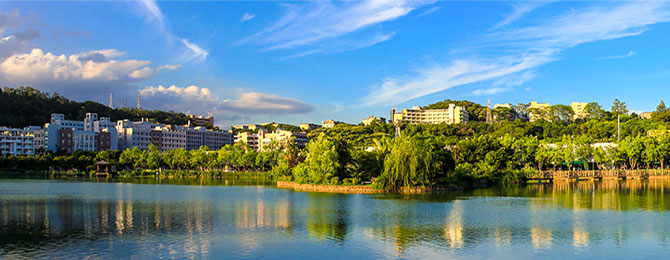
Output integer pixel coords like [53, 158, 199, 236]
[0, 127, 35, 156]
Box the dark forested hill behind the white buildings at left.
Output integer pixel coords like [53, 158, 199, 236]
[0, 87, 188, 127]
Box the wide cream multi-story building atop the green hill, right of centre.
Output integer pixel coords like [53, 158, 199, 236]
[391, 104, 470, 124]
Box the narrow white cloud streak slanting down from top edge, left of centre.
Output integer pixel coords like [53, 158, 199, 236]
[138, 0, 209, 63]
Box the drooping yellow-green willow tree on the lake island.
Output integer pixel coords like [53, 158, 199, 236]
[373, 137, 454, 191]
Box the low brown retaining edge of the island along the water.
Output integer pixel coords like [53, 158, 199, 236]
[276, 181, 464, 194]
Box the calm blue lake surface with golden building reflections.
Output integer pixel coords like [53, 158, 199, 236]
[0, 179, 670, 259]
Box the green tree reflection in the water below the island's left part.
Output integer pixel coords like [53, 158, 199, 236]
[306, 193, 351, 243]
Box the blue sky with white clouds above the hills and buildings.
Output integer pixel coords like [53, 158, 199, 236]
[0, 0, 670, 128]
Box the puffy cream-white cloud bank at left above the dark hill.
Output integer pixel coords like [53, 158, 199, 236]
[0, 49, 177, 100]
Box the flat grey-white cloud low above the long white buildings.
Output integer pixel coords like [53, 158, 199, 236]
[140, 85, 313, 118]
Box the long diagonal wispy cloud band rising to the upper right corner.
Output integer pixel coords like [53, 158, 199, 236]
[361, 1, 670, 105]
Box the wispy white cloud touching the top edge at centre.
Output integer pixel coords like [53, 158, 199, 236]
[238, 0, 432, 53]
